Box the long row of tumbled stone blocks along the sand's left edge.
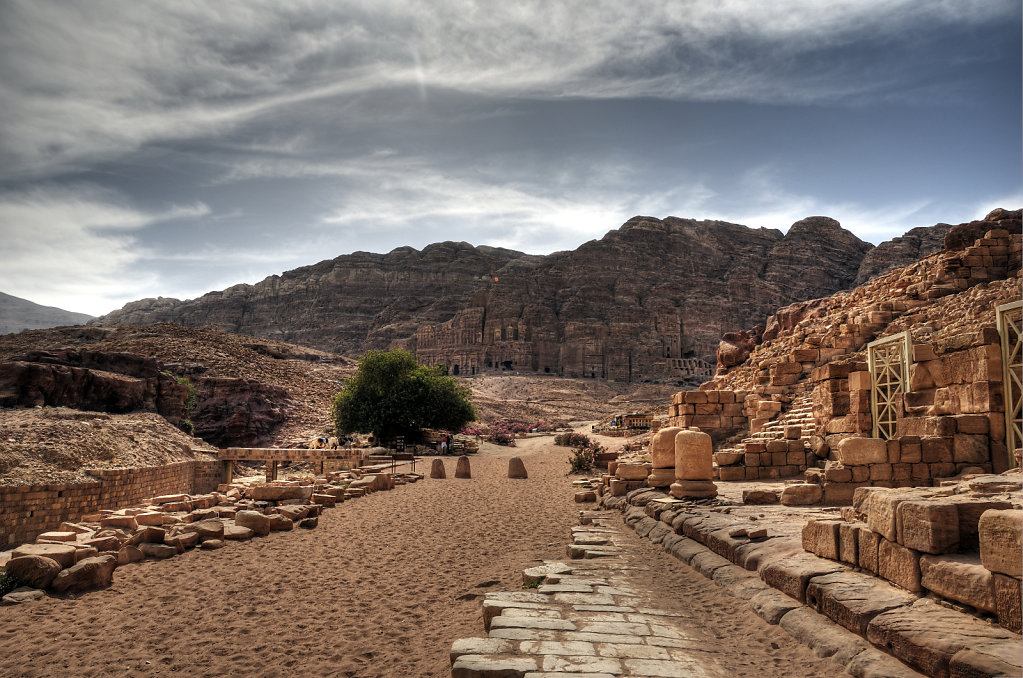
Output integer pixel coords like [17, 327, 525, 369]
[0, 468, 422, 604]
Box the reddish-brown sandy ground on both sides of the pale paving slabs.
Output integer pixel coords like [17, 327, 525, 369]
[0, 438, 834, 678]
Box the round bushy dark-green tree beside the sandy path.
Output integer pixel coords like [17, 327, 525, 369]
[330, 349, 476, 440]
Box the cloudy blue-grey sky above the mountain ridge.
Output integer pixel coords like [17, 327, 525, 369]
[0, 0, 1023, 315]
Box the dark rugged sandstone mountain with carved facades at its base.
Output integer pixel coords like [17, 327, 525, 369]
[92, 217, 940, 381]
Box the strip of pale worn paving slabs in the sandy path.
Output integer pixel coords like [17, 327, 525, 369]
[451, 516, 711, 678]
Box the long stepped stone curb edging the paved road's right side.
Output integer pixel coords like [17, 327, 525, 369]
[601, 490, 1023, 678]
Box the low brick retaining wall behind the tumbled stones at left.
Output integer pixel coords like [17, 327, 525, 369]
[0, 460, 221, 548]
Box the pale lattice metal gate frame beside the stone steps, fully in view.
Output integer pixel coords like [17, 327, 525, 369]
[866, 330, 913, 440]
